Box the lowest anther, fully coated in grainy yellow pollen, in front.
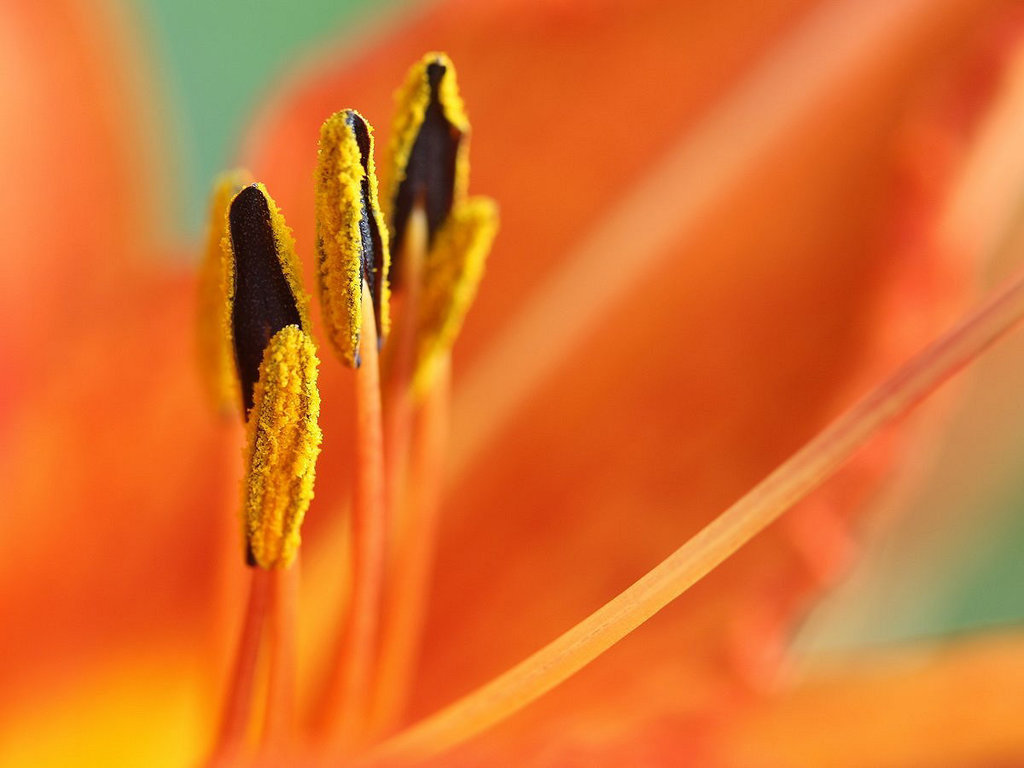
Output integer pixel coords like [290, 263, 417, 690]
[243, 326, 322, 568]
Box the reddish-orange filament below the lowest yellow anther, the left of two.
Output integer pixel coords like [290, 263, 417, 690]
[208, 568, 273, 767]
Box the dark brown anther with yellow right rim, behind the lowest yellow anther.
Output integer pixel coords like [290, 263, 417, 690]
[228, 184, 309, 414]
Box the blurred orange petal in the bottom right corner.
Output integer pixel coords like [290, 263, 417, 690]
[718, 635, 1024, 768]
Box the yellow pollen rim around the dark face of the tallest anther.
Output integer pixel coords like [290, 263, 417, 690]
[385, 51, 469, 222]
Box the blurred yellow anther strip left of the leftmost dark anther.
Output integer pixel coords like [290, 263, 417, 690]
[199, 169, 252, 416]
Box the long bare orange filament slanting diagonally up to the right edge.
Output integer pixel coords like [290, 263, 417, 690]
[370, 264, 1024, 761]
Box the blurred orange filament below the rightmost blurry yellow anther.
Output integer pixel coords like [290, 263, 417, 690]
[371, 360, 451, 734]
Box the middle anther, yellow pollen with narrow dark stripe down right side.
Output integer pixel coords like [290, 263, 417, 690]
[316, 110, 390, 367]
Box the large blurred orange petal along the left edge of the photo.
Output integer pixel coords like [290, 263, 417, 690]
[0, 0, 230, 762]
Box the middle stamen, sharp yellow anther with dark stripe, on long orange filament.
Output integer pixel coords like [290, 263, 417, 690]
[316, 110, 390, 749]
